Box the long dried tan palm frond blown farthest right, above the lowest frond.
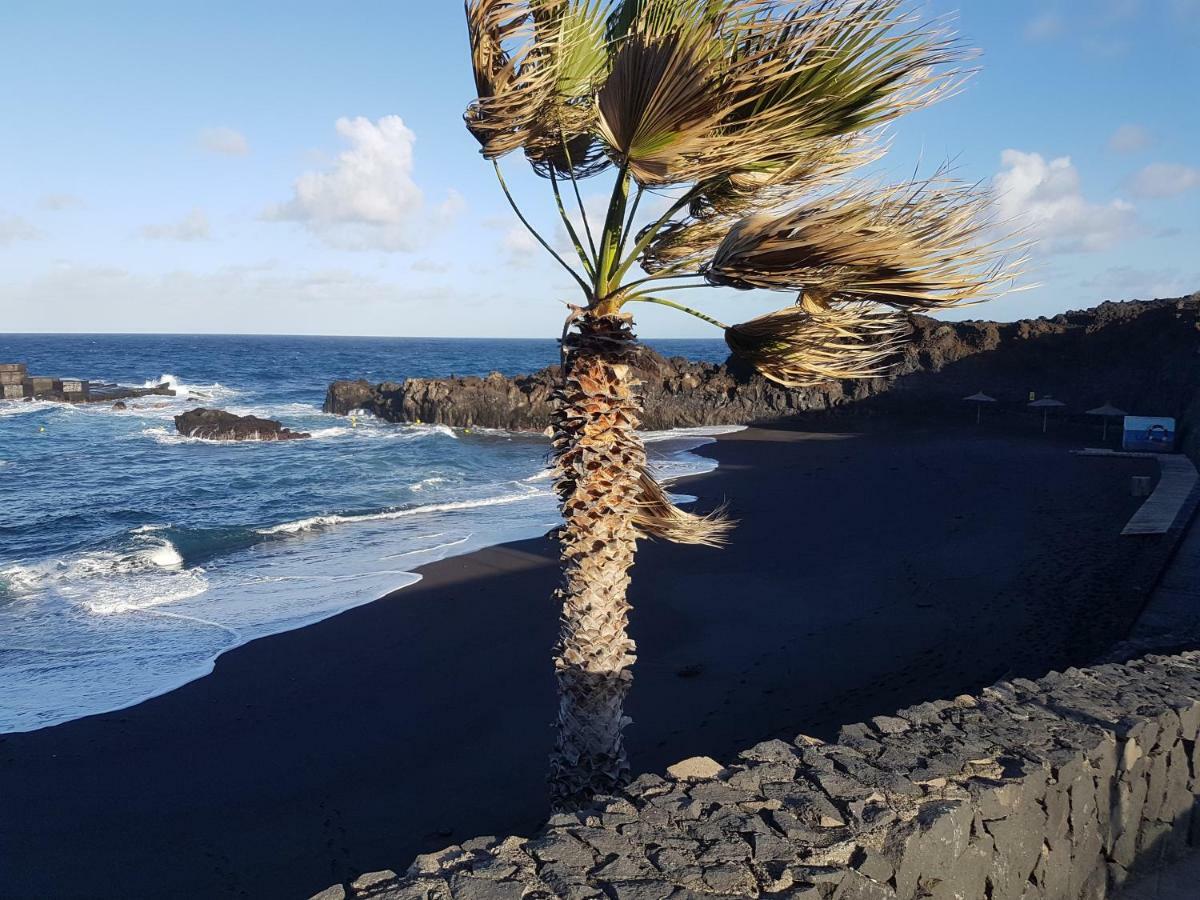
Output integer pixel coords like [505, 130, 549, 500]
[706, 173, 1025, 308]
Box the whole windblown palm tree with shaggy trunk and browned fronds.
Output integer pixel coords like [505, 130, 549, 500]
[466, 0, 1015, 809]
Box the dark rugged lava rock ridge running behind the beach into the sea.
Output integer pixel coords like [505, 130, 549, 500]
[324, 294, 1200, 431]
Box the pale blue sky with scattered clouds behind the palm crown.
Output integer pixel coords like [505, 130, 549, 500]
[0, 0, 1200, 336]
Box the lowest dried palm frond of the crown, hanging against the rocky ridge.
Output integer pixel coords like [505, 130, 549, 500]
[725, 302, 911, 388]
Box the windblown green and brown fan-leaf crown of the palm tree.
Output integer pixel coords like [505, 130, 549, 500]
[466, 0, 1019, 386]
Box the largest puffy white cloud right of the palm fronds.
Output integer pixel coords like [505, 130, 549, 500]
[992, 150, 1136, 253]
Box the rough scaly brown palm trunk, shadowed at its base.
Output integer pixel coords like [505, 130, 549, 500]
[550, 313, 646, 810]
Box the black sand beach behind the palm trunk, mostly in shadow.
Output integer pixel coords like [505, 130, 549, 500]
[0, 428, 1154, 900]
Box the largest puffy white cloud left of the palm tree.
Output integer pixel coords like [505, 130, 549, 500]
[264, 115, 466, 251]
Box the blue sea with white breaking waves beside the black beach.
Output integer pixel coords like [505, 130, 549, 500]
[0, 335, 726, 732]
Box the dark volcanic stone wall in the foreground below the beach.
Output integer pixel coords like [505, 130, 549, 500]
[318, 652, 1200, 900]
